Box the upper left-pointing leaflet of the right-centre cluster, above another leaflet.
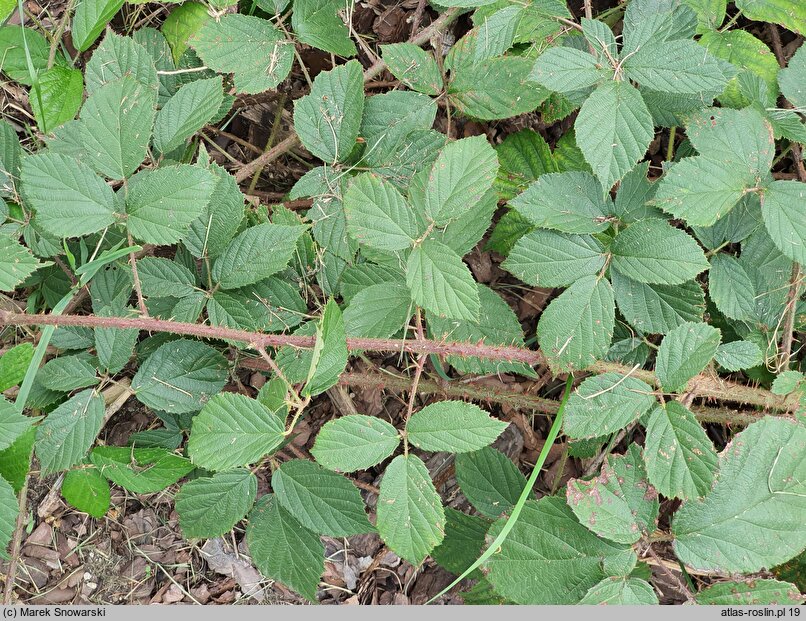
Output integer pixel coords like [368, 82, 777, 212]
[509, 171, 610, 233]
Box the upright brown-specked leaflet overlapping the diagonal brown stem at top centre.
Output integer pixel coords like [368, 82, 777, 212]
[294, 60, 364, 163]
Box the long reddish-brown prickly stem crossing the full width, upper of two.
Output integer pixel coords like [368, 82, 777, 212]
[0, 310, 797, 412]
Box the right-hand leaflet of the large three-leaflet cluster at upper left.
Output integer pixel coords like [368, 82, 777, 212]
[126, 164, 216, 245]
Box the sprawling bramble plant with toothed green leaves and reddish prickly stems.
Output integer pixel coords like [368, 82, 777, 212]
[0, 0, 806, 604]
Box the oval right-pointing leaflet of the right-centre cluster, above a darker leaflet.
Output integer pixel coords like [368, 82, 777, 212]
[610, 220, 709, 285]
